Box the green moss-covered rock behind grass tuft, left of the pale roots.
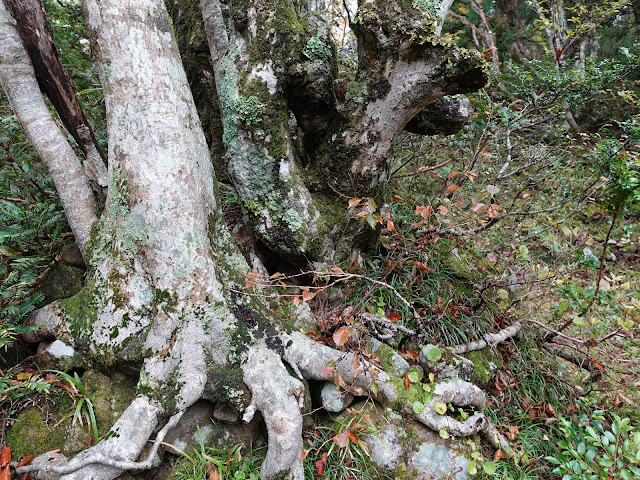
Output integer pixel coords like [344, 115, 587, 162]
[6, 370, 135, 459]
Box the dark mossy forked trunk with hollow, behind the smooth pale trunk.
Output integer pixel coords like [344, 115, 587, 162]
[172, 0, 486, 265]
